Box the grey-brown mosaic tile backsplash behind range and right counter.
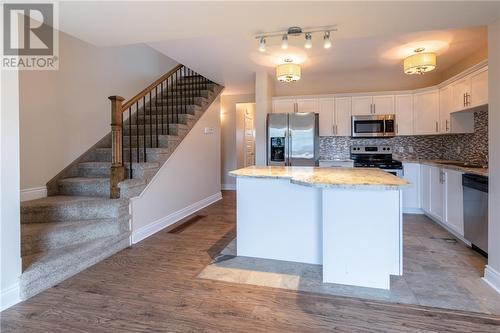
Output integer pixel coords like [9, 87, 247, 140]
[319, 108, 488, 164]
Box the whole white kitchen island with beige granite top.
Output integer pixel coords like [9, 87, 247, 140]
[230, 166, 407, 289]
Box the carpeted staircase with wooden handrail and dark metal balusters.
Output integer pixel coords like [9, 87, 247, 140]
[21, 65, 223, 299]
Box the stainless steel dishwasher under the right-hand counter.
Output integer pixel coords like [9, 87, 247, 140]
[462, 174, 488, 255]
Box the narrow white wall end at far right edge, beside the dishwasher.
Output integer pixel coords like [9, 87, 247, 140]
[485, 20, 500, 293]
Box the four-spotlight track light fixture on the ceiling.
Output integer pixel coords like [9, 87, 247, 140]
[255, 26, 337, 52]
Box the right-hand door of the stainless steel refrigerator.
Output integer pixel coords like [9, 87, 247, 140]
[288, 113, 316, 166]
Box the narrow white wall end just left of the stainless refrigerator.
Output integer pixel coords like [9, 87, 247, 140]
[255, 71, 274, 165]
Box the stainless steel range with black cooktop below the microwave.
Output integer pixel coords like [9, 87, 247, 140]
[351, 146, 403, 177]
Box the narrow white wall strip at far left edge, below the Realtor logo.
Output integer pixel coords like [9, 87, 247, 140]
[0, 70, 21, 311]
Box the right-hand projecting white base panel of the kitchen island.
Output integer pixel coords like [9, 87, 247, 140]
[322, 189, 403, 289]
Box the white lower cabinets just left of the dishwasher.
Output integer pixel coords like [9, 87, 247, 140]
[416, 165, 464, 236]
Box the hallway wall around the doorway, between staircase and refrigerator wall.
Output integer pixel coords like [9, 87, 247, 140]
[220, 94, 255, 189]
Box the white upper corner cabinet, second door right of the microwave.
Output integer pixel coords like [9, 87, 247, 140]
[413, 90, 439, 135]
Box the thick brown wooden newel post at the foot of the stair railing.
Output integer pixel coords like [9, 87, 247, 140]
[109, 96, 125, 199]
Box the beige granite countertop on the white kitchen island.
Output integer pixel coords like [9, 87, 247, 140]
[229, 166, 409, 190]
